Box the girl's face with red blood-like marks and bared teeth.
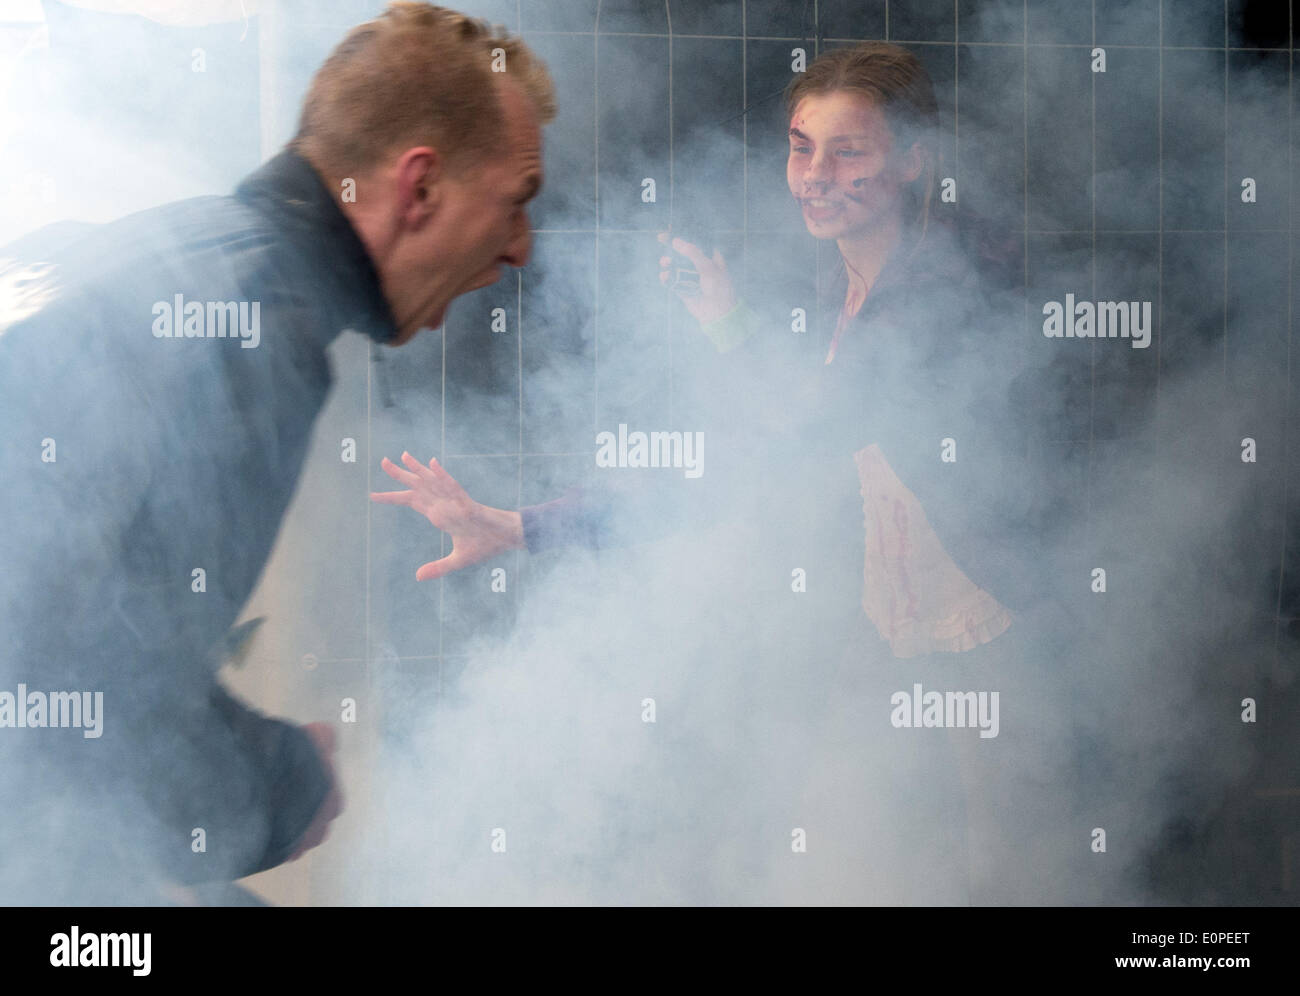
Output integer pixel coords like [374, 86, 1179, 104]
[785, 90, 924, 239]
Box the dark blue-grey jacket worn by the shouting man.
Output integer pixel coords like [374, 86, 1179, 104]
[0, 151, 395, 902]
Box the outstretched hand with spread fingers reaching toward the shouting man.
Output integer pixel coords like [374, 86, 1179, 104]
[371, 452, 524, 581]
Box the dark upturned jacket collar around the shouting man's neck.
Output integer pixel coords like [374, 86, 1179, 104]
[235, 148, 397, 343]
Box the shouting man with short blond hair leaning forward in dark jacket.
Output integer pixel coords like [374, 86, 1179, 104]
[0, 3, 555, 905]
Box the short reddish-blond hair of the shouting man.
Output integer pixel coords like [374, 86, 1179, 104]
[290, 0, 555, 177]
